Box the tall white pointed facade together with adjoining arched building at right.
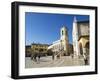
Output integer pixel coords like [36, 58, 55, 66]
[72, 18, 90, 56]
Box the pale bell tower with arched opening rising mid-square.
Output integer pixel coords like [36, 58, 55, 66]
[60, 26, 69, 55]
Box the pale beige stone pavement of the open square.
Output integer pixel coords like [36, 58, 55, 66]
[25, 56, 84, 68]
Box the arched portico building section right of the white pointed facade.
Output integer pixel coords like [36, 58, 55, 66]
[78, 21, 90, 55]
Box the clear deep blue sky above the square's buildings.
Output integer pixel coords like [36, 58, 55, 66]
[25, 12, 89, 45]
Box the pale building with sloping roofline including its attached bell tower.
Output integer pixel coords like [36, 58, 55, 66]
[48, 26, 69, 55]
